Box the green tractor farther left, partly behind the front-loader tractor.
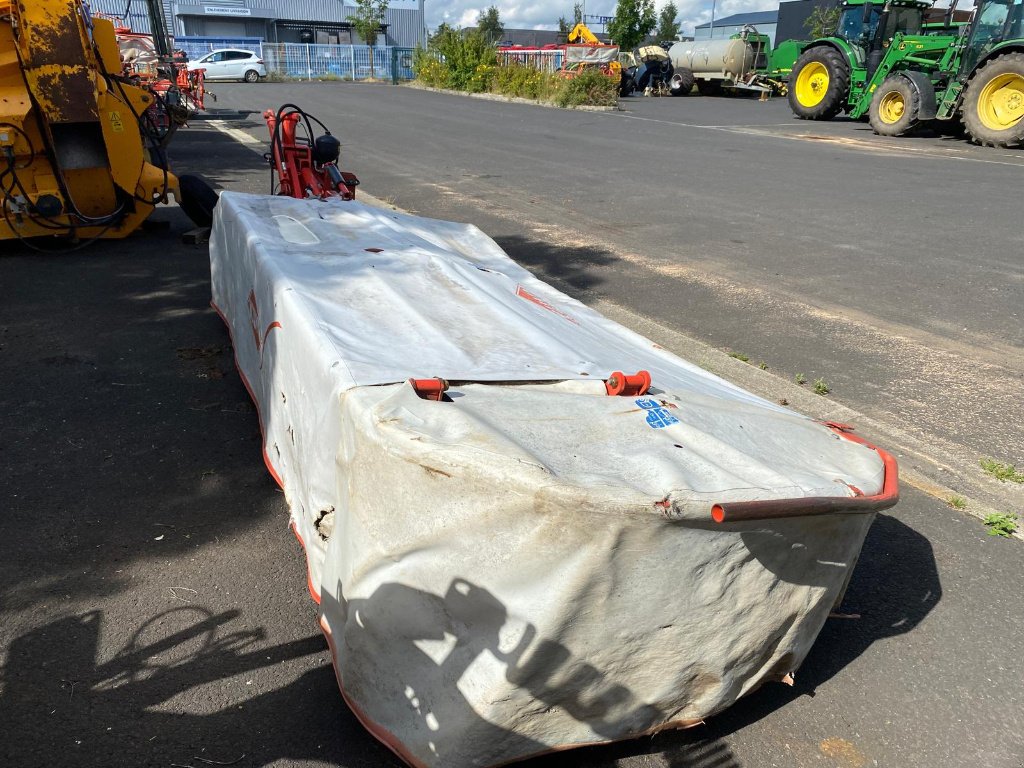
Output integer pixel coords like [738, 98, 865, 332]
[787, 0, 941, 120]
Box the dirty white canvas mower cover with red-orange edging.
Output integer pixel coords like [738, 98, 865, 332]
[210, 193, 895, 768]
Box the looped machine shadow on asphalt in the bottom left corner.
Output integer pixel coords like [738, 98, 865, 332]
[0, 606, 385, 768]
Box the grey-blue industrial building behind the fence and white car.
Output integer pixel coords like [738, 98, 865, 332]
[91, 0, 426, 47]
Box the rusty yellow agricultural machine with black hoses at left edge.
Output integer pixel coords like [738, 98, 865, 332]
[0, 0, 205, 250]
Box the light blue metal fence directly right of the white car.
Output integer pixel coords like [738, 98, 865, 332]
[262, 43, 414, 82]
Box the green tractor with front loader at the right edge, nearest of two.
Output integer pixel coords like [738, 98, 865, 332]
[850, 0, 1024, 146]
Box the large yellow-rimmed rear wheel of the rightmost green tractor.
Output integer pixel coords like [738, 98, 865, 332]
[964, 53, 1024, 147]
